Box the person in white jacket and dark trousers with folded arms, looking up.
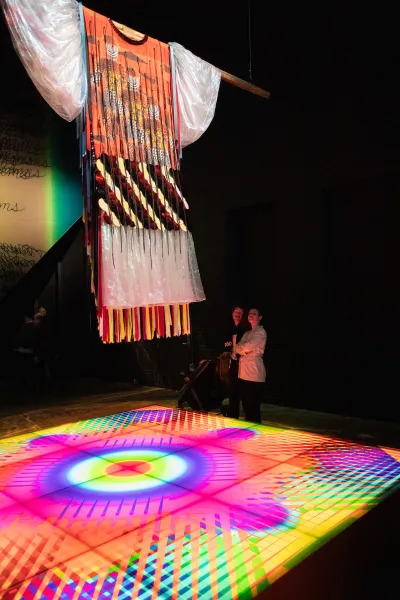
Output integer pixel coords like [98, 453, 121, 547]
[235, 308, 267, 423]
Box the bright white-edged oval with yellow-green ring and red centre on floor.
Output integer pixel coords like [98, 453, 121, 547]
[66, 449, 187, 494]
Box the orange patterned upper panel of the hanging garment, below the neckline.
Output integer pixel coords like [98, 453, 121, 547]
[83, 7, 177, 168]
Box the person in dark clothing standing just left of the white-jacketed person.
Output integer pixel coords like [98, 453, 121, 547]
[224, 306, 249, 419]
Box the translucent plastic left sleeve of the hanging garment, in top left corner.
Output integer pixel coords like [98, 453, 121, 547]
[2, 0, 87, 121]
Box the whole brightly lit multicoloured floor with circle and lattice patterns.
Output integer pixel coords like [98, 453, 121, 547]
[0, 407, 400, 600]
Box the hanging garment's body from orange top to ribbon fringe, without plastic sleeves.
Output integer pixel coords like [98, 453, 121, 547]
[82, 8, 204, 342]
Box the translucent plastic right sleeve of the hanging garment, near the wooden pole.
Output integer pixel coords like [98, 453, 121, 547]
[170, 42, 221, 148]
